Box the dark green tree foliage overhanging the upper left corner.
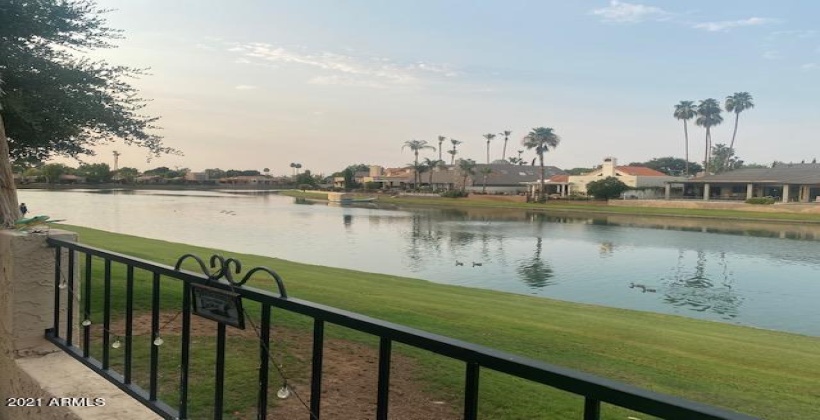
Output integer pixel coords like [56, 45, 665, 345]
[0, 0, 175, 161]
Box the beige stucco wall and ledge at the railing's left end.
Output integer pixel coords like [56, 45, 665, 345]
[0, 230, 161, 420]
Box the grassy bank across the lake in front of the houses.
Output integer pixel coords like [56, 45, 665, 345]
[280, 190, 820, 224]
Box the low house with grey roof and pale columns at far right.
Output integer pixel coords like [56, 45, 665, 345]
[683, 163, 820, 203]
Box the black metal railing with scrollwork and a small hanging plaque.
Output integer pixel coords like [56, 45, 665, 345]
[46, 238, 753, 420]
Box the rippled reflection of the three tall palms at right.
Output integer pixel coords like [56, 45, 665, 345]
[664, 250, 743, 319]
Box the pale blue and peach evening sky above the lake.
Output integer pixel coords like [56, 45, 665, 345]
[57, 0, 820, 175]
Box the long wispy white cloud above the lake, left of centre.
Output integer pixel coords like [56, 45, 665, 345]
[228, 42, 460, 88]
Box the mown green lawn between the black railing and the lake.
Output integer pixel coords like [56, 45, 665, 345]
[60, 226, 820, 420]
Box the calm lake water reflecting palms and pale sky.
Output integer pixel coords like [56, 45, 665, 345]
[19, 190, 820, 336]
